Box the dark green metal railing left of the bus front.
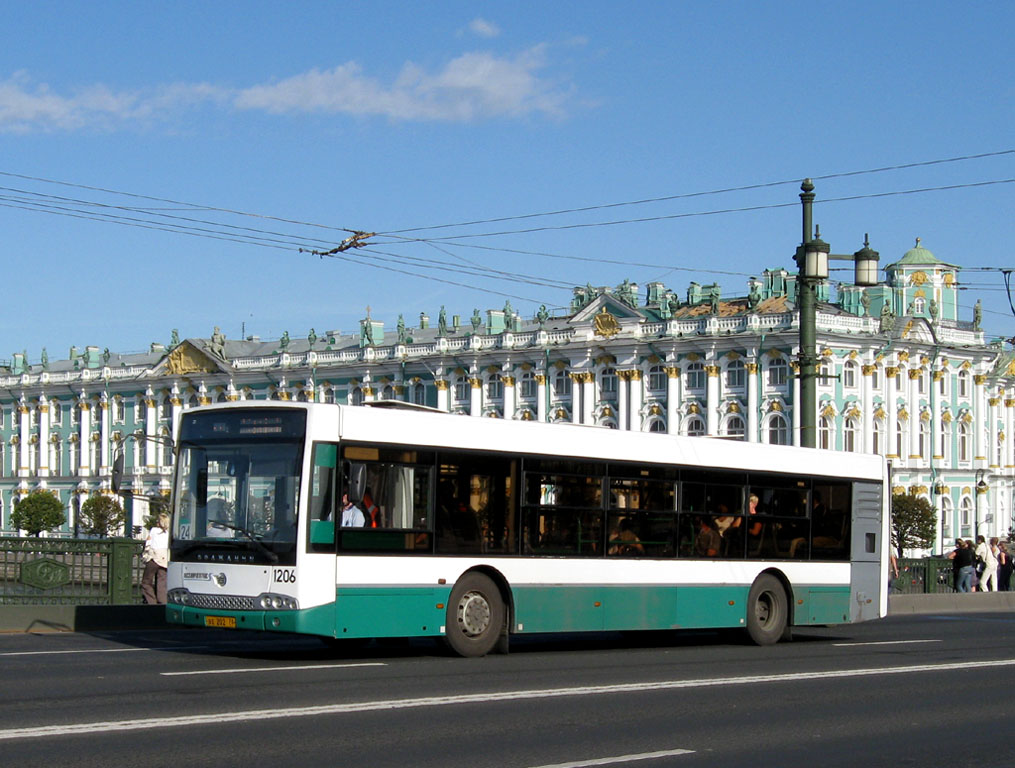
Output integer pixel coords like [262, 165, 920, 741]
[0, 538, 144, 606]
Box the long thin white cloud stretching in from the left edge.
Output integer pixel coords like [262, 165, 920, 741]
[0, 45, 572, 133]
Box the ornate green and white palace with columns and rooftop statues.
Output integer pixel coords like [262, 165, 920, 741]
[0, 240, 1015, 552]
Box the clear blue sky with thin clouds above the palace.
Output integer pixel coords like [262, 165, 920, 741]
[0, 0, 1015, 360]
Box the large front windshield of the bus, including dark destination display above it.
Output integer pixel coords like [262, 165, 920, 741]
[172, 409, 306, 564]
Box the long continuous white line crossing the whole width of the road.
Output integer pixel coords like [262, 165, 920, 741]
[0, 658, 1015, 741]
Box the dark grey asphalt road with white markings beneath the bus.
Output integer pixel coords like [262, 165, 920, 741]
[0, 613, 1015, 768]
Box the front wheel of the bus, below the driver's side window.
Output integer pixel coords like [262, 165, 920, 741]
[445, 573, 504, 656]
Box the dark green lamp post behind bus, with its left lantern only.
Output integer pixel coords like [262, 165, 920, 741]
[796, 179, 830, 448]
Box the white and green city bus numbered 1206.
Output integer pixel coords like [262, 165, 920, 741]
[166, 401, 889, 656]
